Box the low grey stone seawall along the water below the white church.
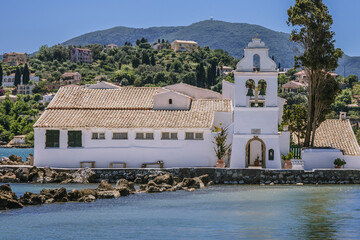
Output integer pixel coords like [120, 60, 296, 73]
[88, 168, 360, 184]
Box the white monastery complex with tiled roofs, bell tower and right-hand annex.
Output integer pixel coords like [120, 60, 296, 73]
[34, 38, 360, 169]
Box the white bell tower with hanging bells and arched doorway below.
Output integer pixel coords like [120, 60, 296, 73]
[230, 37, 281, 169]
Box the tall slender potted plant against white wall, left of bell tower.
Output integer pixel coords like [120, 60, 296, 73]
[213, 123, 231, 168]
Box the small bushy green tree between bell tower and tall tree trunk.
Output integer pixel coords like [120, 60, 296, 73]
[282, 105, 307, 145]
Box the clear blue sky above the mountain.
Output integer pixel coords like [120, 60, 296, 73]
[0, 0, 360, 56]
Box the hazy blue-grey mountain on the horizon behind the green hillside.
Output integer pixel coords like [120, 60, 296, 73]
[63, 20, 360, 76]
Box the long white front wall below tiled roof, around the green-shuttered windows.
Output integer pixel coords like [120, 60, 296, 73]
[34, 128, 217, 168]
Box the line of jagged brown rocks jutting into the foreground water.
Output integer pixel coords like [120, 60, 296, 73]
[0, 173, 212, 210]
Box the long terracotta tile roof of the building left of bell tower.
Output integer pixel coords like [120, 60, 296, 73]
[34, 87, 232, 128]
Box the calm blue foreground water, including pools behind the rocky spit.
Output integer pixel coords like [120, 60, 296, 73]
[0, 184, 360, 239]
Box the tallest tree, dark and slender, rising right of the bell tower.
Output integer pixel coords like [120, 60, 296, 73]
[287, 0, 343, 147]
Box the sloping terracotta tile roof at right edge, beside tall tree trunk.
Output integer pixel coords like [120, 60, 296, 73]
[293, 119, 360, 155]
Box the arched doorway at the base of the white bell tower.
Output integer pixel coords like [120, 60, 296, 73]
[245, 136, 266, 168]
